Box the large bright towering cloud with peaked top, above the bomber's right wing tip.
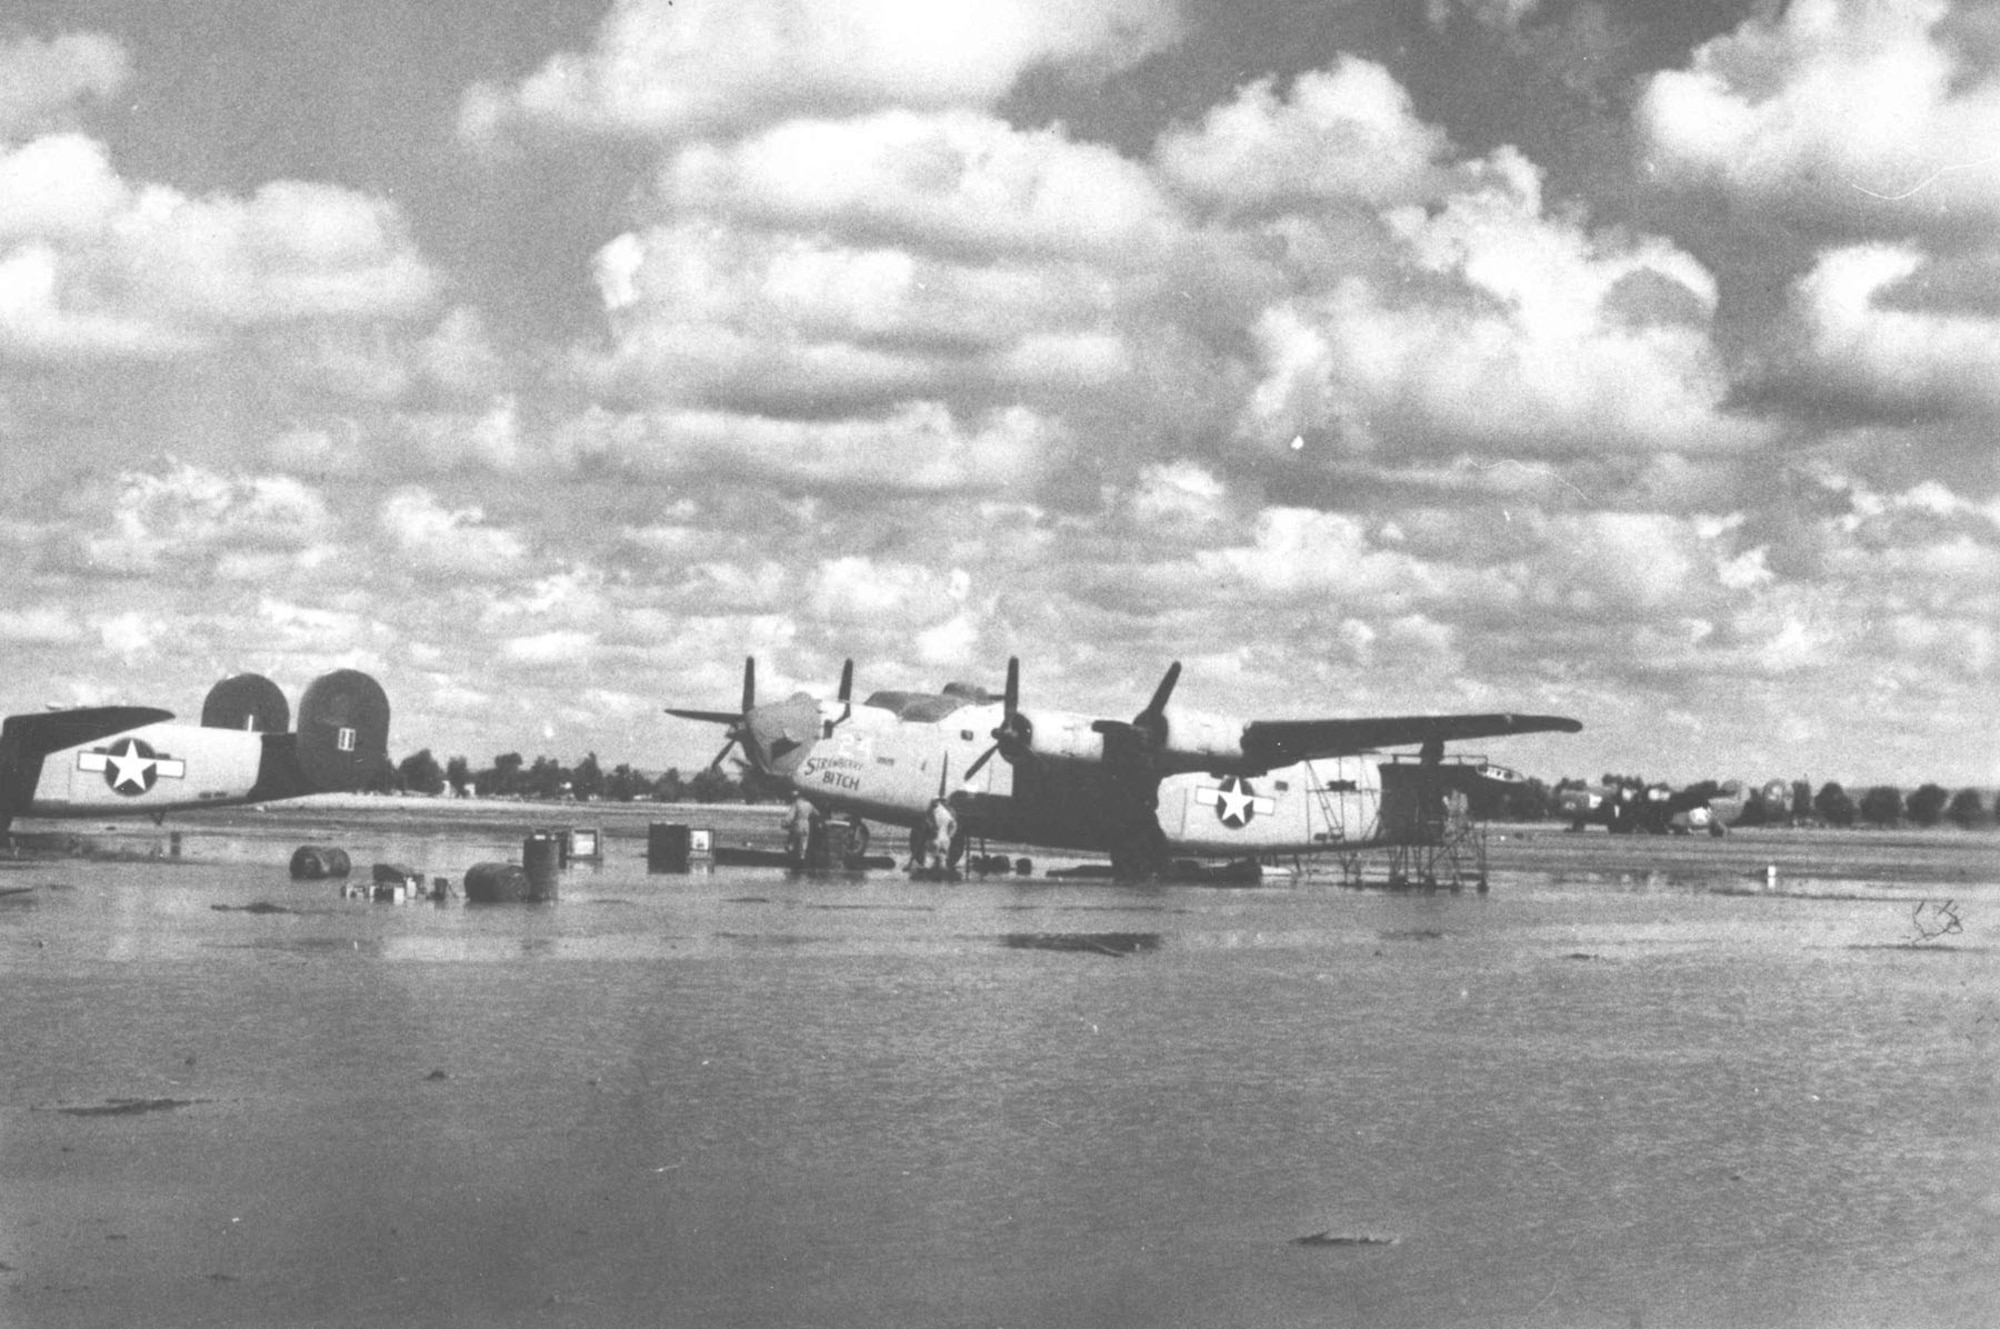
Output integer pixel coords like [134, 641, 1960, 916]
[1240, 150, 1764, 458]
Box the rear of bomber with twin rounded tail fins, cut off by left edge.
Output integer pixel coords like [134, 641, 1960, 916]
[0, 669, 388, 831]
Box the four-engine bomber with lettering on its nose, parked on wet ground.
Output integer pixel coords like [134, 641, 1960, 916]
[668, 658, 1582, 877]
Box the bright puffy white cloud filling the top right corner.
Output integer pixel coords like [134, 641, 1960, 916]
[1638, 0, 2000, 238]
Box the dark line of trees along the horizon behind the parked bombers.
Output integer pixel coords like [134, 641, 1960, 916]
[382, 749, 2000, 829]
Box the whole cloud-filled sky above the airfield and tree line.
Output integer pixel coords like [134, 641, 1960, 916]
[0, 0, 2000, 787]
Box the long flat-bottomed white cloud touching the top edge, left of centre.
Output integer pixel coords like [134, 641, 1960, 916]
[460, 0, 1180, 142]
